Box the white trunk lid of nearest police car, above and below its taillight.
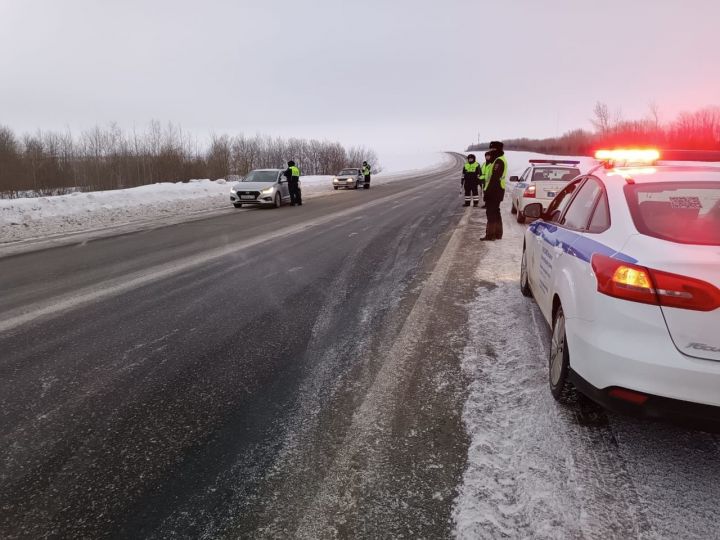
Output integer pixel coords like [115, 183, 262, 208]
[623, 235, 720, 361]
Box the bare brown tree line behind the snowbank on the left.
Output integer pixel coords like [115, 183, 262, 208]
[0, 121, 379, 197]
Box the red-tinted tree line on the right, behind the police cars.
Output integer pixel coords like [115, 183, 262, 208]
[468, 102, 720, 155]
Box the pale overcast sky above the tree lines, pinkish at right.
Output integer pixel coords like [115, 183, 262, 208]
[0, 0, 720, 155]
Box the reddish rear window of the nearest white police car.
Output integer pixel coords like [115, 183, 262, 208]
[625, 182, 720, 246]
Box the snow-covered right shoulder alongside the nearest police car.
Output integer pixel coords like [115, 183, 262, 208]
[454, 153, 720, 539]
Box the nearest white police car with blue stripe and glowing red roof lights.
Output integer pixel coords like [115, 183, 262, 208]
[520, 151, 720, 426]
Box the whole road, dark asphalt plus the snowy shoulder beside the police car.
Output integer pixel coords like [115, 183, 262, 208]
[5, 154, 720, 540]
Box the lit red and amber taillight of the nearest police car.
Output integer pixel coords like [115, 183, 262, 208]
[591, 253, 720, 311]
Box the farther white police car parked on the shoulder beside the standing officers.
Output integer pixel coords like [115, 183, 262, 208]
[510, 159, 580, 223]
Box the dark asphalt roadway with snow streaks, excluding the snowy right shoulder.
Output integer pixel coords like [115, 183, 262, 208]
[0, 157, 484, 538]
